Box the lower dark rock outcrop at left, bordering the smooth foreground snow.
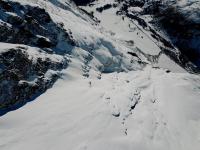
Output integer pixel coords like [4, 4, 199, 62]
[0, 47, 69, 113]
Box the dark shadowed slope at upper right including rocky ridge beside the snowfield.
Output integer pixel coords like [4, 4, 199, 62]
[116, 0, 200, 73]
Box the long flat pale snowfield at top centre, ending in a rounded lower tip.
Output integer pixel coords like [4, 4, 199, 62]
[83, 0, 160, 55]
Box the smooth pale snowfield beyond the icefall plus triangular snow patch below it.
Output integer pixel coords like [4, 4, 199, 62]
[82, 0, 188, 72]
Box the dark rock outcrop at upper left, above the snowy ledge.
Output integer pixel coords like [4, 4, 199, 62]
[0, 1, 75, 48]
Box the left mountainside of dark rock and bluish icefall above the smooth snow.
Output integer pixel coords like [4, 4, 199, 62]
[0, 0, 146, 112]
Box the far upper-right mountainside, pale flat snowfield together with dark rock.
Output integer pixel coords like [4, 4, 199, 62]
[82, 0, 199, 73]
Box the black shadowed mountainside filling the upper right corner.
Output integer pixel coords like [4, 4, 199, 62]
[144, 1, 200, 70]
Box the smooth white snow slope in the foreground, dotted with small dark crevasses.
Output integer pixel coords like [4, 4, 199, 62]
[0, 66, 200, 150]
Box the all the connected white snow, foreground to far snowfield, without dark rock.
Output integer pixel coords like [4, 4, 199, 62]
[0, 0, 200, 150]
